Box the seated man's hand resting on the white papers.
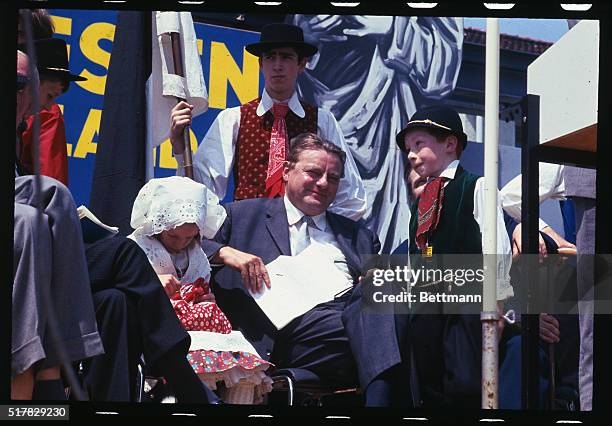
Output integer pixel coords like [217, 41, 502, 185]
[213, 246, 270, 293]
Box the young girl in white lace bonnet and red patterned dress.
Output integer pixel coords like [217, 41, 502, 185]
[128, 176, 271, 403]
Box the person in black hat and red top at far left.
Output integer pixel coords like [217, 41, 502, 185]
[18, 38, 87, 185]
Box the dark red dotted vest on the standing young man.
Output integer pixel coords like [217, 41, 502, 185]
[234, 98, 317, 200]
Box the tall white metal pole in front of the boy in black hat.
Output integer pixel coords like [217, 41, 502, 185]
[480, 18, 499, 409]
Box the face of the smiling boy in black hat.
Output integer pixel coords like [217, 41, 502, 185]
[404, 128, 457, 178]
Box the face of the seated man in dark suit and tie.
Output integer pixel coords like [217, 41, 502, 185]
[283, 149, 343, 216]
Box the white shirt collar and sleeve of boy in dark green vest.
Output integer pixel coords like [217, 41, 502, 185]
[432, 160, 514, 301]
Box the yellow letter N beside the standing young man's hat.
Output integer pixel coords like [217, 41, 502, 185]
[208, 41, 259, 109]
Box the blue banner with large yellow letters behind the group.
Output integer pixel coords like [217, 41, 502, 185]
[49, 9, 263, 205]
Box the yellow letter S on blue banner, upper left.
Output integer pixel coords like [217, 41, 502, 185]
[76, 22, 115, 95]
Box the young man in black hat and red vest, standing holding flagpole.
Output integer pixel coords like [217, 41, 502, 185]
[170, 23, 366, 220]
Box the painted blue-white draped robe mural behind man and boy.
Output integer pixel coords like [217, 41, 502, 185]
[290, 15, 463, 250]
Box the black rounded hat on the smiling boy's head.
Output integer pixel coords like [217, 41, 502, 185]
[395, 106, 467, 152]
